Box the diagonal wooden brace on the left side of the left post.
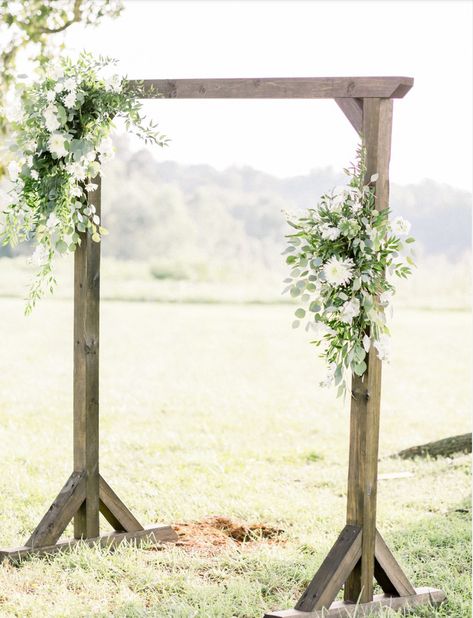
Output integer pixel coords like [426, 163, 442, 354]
[25, 472, 85, 548]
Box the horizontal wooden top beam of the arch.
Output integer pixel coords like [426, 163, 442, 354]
[130, 76, 414, 99]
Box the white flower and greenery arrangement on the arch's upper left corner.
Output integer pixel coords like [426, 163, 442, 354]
[1, 53, 167, 313]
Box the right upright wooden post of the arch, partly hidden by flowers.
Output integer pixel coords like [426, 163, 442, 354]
[344, 98, 393, 603]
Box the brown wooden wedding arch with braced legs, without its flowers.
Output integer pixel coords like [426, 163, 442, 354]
[0, 77, 445, 618]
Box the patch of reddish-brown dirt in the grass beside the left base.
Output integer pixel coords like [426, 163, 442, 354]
[173, 515, 284, 554]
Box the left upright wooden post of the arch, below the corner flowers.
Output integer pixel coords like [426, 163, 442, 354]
[74, 177, 101, 539]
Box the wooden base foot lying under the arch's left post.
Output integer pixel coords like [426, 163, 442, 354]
[0, 526, 178, 562]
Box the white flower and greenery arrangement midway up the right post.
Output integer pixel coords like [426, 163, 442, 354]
[284, 147, 414, 396]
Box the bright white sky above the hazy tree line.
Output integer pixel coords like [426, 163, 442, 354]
[66, 0, 473, 190]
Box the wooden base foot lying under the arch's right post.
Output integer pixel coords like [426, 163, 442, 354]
[264, 588, 446, 618]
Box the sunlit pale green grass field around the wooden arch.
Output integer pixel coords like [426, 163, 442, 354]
[0, 298, 471, 618]
